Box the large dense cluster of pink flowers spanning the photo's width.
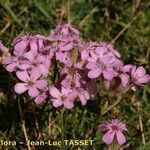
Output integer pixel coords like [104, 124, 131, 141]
[0, 24, 150, 109]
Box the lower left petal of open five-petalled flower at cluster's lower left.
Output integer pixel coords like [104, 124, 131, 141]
[14, 83, 28, 94]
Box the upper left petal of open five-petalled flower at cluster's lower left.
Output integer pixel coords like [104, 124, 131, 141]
[16, 71, 30, 82]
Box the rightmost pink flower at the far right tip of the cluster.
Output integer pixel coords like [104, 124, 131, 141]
[131, 66, 150, 86]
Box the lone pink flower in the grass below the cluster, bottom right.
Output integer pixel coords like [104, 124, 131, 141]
[99, 119, 128, 145]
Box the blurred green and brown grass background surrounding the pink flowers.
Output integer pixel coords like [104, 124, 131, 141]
[0, 0, 150, 150]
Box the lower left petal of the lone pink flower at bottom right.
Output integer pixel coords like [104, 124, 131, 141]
[103, 132, 115, 144]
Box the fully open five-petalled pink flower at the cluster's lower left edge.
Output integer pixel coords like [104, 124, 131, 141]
[14, 71, 47, 97]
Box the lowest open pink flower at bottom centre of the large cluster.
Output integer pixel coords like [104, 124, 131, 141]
[50, 86, 77, 109]
